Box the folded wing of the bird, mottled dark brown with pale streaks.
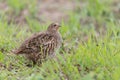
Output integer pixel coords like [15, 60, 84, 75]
[17, 32, 56, 54]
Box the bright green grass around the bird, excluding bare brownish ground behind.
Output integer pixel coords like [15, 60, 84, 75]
[0, 0, 120, 80]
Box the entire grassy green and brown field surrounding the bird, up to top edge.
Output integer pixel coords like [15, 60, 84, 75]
[0, 0, 120, 80]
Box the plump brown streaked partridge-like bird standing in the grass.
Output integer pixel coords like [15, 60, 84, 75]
[13, 23, 62, 64]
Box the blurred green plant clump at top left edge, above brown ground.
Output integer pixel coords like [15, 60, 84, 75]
[7, 0, 37, 15]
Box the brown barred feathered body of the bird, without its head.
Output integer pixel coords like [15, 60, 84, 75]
[16, 33, 62, 63]
